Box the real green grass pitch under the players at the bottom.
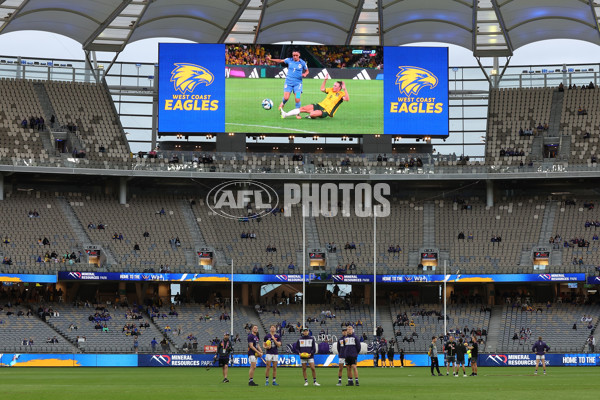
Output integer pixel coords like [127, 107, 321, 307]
[0, 367, 600, 400]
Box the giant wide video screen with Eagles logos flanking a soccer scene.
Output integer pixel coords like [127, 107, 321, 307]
[158, 43, 449, 137]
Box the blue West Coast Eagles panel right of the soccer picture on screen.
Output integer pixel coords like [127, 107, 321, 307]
[383, 47, 449, 137]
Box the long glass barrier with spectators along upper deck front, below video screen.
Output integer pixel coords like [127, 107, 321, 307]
[0, 152, 600, 175]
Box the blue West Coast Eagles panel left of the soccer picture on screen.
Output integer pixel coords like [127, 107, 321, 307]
[158, 43, 225, 133]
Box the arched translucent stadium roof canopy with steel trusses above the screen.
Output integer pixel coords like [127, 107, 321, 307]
[0, 0, 600, 57]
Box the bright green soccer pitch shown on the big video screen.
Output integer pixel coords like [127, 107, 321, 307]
[225, 79, 383, 135]
